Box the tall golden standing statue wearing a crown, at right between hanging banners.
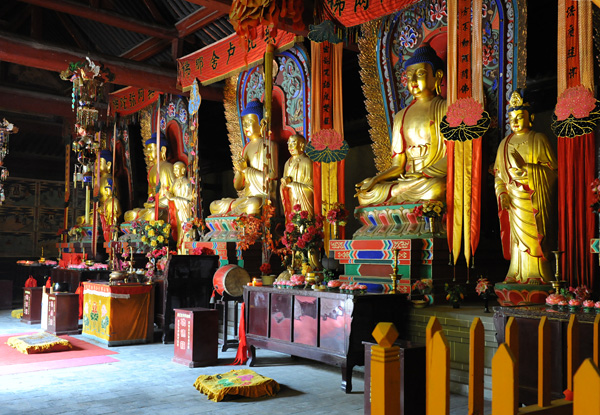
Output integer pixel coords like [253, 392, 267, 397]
[494, 91, 558, 284]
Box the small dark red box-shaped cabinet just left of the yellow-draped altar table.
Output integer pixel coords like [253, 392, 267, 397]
[46, 293, 79, 335]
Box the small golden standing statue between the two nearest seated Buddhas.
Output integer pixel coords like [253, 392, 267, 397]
[279, 134, 315, 218]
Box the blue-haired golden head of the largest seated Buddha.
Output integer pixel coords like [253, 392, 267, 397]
[405, 43, 445, 99]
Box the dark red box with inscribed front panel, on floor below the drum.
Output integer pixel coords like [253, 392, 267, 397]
[173, 307, 219, 367]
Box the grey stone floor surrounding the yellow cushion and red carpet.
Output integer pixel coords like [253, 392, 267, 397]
[0, 310, 491, 415]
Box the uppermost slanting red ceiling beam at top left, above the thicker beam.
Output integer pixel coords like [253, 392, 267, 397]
[20, 0, 177, 40]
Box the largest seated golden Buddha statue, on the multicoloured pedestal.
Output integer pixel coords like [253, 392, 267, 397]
[356, 45, 447, 206]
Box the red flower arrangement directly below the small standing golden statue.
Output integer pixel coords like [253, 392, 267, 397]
[281, 204, 323, 262]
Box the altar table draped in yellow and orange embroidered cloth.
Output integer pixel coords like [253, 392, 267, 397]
[82, 282, 154, 346]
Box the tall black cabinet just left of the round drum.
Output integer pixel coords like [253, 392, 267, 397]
[154, 255, 219, 343]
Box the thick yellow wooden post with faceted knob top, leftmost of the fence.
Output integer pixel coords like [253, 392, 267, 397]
[371, 323, 398, 415]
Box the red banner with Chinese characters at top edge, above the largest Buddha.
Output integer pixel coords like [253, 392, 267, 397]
[324, 0, 418, 27]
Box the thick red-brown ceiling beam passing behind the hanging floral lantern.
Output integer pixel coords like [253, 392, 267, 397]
[0, 32, 223, 102]
